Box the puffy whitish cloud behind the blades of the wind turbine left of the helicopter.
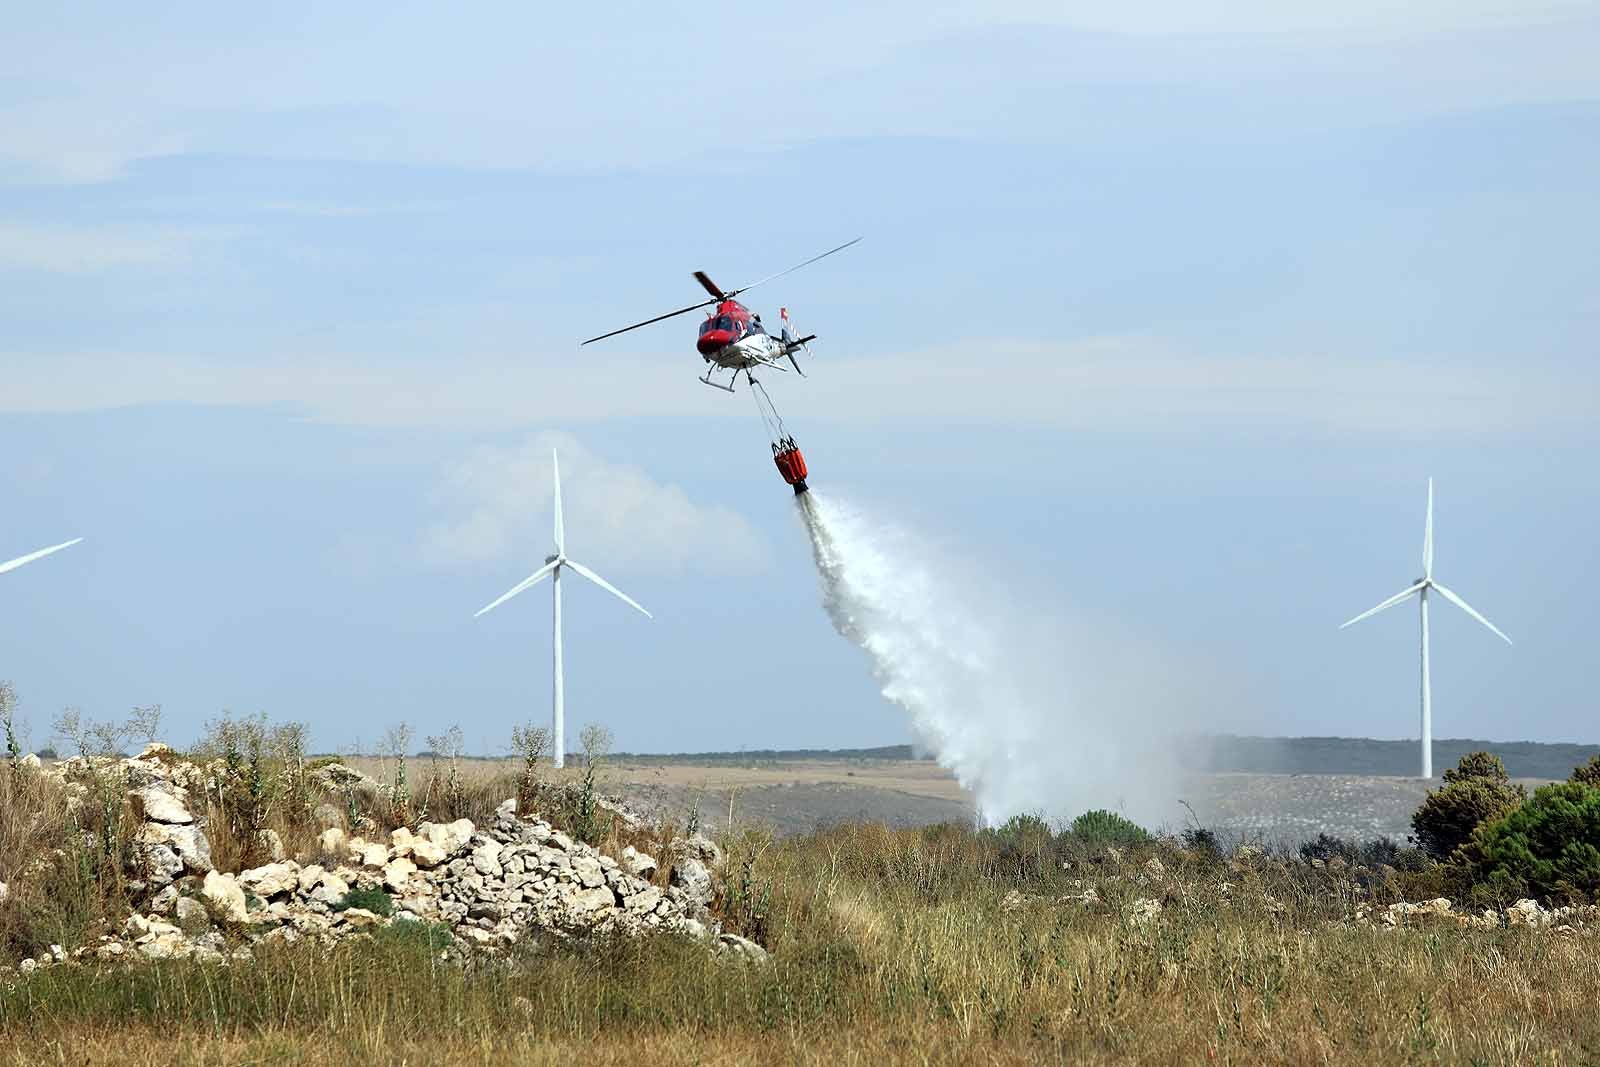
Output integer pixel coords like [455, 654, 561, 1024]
[422, 432, 770, 573]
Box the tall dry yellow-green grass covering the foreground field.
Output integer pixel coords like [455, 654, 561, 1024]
[0, 825, 1600, 1064]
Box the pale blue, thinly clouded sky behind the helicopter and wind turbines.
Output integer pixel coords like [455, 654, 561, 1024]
[0, 0, 1600, 752]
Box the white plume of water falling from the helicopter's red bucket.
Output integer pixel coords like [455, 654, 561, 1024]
[795, 490, 1178, 825]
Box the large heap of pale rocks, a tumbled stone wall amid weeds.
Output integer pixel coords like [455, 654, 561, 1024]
[1, 745, 766, 971]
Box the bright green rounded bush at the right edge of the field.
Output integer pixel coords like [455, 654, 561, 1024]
[1472, 782, 1600, 901]
